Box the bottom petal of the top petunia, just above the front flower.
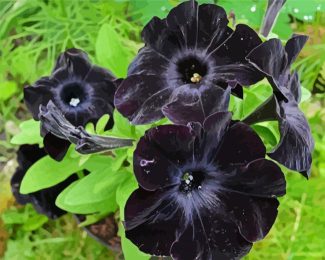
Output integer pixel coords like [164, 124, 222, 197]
[162, 84, 230, 125]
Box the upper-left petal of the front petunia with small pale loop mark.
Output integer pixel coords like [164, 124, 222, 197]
[133, 125, 193, 190]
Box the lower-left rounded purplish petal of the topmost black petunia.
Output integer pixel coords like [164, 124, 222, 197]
[114, 75, 168, 124]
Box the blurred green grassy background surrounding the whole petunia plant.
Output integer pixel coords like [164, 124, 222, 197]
[0, 0, 325, 260]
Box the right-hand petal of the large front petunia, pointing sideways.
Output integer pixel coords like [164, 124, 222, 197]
[221, 158, 286, 198]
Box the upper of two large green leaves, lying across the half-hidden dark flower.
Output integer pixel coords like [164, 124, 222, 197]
[20, 156, 81, 194]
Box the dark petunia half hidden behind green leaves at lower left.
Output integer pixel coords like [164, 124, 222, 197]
[11, 145, 78, 219]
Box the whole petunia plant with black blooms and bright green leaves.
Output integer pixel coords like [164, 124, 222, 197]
[12, 1, 314, 260]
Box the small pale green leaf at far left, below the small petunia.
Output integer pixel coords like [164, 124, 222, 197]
[10, 119, 43, 144]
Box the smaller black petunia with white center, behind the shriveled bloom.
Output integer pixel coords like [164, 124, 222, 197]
[24, 49, 116, 160]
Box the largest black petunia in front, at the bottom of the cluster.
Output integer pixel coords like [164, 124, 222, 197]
[125, 112, 286, 260]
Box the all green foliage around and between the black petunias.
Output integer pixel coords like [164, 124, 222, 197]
[0, 0, 325, 259]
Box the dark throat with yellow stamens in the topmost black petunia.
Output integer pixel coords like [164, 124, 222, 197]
[177, 57, 207, 84]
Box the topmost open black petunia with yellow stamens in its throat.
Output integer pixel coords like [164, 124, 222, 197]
[114, 1, 263, 124]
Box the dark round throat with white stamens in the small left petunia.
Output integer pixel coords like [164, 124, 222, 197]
[60, 82, 87, 107]
